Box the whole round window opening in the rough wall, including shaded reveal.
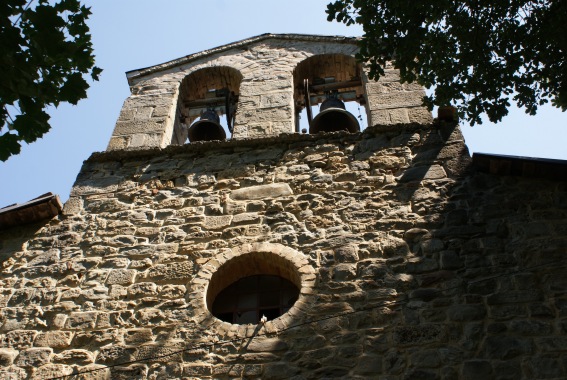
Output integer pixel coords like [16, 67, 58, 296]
[206, 252, 301, 324]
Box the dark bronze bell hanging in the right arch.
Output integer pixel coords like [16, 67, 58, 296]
[309, 97, 360, 133]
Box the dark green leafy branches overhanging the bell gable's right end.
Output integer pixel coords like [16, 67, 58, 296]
[326, 0, 567, 125]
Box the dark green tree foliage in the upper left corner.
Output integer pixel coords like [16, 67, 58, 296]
[0, 0, 101, 161]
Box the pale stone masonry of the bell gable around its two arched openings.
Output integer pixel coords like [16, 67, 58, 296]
[107, 34, 432, 150]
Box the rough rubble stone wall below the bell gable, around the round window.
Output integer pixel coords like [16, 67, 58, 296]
[0, 124, 567, 379]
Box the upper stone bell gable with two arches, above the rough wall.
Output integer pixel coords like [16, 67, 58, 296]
[108, 34, 431, 150]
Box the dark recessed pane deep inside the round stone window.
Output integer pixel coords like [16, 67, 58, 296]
[212, 275, 299, 324]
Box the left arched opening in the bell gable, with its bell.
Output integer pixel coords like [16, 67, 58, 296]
[176, 66, 242, 142]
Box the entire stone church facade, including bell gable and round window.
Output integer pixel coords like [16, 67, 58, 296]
[0, 34, 567, 380]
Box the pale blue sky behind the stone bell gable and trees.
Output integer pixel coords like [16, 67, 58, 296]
[0, 0, 567, 207]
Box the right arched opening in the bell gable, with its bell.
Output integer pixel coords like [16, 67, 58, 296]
[294, 54, 367, 133]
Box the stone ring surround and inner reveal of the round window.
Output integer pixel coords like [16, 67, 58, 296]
[188, 243, 316, 337]
